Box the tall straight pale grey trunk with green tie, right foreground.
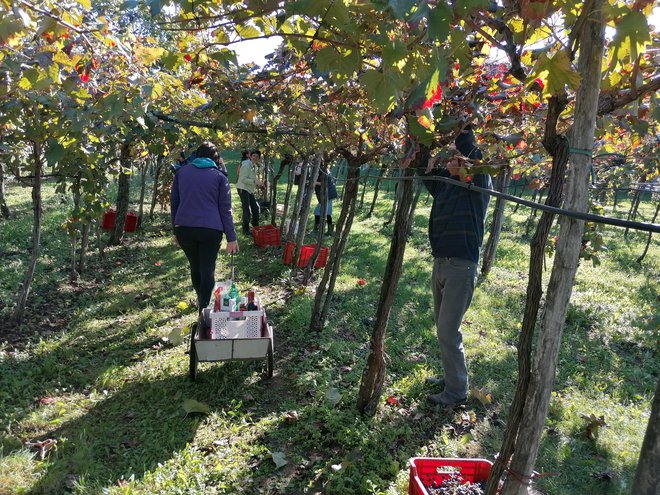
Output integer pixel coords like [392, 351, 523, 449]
[502, 0, 605, 495]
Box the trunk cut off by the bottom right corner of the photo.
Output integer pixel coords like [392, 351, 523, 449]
[630, 379, 660, 495]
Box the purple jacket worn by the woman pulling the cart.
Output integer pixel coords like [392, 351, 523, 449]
[170, 164, 236, 242]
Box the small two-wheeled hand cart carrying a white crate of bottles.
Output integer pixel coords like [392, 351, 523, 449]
[189, 256, 274, 381]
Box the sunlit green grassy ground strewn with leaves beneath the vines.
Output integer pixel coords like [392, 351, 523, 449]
[0, 174, 660, 495]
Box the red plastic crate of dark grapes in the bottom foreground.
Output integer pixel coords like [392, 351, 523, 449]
[408, 457, 493, 495]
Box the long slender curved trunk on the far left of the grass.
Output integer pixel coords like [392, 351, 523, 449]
[12, 141, 43, 325]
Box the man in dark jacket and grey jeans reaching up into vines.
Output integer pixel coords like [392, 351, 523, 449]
[419, 126, 492, 407]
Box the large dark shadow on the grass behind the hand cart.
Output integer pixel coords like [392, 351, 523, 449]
[24, 357, 282, 495]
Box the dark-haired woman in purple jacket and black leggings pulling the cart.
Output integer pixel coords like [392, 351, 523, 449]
[170, 142, 238, 322]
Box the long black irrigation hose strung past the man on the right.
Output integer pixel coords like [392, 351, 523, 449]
[356, 175, 660, 233]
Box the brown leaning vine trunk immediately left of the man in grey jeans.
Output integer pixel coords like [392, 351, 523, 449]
[357, 165, 415, 416]
